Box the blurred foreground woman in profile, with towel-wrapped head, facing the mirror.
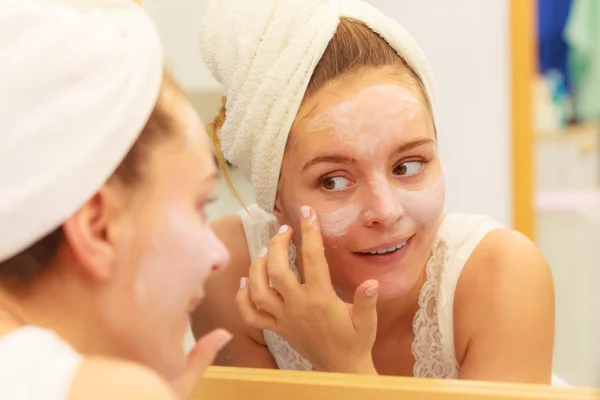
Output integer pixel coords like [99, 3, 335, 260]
[0, 0, 231, 400]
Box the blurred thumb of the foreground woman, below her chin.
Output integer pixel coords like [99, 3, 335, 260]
[172, 329, 233, 399]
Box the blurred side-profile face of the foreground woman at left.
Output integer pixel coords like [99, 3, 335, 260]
[98, 90, 229, 377]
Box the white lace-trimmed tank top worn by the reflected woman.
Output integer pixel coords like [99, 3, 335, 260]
[239, 205, 503, 379]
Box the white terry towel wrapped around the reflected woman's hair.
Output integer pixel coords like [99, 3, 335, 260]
[201, 0, 434, 212]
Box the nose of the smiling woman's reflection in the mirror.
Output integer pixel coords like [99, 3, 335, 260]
[363, 180, 406, 227]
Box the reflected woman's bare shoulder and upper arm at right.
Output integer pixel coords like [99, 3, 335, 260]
[454, 229, 554, 384]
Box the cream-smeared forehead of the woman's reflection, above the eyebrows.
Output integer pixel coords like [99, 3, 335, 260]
[290, 79, 435, 149]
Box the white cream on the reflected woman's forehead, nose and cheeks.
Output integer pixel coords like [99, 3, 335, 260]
[308, 84, 445, 238]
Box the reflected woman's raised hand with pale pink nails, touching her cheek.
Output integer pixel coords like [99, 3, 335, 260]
[236, 206, 379, 374]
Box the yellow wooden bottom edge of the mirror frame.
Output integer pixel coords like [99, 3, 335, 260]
[191, 367, 600, 400]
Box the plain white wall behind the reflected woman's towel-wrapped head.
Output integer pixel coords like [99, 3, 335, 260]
[144, 0, 512, 225]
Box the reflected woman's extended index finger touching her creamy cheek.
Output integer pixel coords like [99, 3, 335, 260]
[300, 206, 333, 292]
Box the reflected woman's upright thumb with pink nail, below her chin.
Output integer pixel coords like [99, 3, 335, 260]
[352, 279, 379, 336]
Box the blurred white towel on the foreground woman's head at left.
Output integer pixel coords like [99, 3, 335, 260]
[0, 0, 163, 262]
